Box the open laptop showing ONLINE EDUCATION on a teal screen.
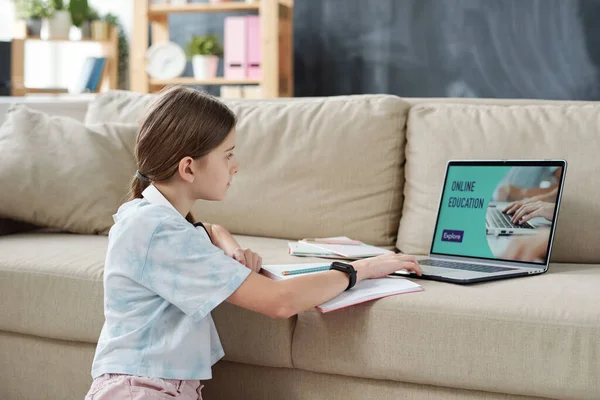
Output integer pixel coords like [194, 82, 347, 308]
[396, 160, 567, 284]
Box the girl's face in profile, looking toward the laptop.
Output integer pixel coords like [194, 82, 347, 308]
[194, 128, 239, 200]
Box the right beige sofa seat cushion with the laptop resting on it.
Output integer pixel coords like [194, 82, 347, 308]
[292, 264, 600, 399]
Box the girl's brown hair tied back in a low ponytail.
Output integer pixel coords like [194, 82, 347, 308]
[129, 86, 236, 222]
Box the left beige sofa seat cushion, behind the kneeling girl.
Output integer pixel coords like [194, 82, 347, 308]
[0, 233, 315, 367]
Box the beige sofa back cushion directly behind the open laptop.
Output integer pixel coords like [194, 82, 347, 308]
[397, 102, 600, 263]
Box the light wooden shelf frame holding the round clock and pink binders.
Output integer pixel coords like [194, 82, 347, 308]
[129, 0, 294, 98]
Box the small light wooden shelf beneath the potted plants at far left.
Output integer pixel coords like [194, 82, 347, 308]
[11, 21, 119, 96]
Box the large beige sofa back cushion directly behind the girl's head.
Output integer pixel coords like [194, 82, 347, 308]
[86, 92, 408, 245]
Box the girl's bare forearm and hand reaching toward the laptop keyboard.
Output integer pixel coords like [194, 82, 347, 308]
[227, 254, 421, 318]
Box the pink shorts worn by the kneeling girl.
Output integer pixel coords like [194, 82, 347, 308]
[85, 374, 204, 400]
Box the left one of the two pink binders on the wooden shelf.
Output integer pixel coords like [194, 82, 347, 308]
[223, 17, 247, 79]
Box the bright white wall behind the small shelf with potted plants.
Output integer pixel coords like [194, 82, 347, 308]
[0, 0, 133, 87]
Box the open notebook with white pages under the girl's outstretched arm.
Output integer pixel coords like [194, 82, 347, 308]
[262, 263, 423, 313]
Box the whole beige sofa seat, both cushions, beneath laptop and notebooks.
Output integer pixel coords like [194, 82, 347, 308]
[0, 233, 600, 399]
